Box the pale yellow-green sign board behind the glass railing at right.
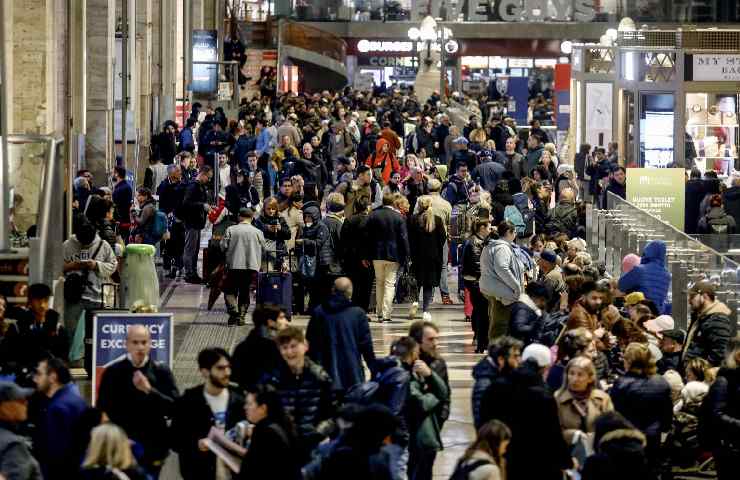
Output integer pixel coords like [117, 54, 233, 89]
[627, 168, 686, 231]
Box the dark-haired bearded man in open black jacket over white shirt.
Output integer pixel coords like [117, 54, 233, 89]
[171, 348, 244, 480]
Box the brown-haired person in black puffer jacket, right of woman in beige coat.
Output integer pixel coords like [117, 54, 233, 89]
[609, 343, 673, 466]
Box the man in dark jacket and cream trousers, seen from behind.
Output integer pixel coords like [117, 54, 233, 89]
[364, 194, 409, 322]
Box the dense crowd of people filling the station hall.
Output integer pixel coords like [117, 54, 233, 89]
[0, 82, 740, 480]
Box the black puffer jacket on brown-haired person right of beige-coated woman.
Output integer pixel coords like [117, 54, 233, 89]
[609, 372, 673, 446]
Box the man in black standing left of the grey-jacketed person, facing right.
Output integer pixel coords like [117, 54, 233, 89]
[182, 165, 213, 283]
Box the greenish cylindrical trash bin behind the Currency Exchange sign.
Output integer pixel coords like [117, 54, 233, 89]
[121, 243, 159, 308]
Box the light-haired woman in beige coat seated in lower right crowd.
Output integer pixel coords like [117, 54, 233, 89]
[555, 357, 614, 444]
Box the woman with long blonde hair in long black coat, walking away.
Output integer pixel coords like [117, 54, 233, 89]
[408, 195, 447, 320]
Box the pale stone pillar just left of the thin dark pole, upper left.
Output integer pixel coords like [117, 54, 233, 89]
[85, 0, 116, 184]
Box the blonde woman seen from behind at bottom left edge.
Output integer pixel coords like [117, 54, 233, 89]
[80, 423, 148, 480]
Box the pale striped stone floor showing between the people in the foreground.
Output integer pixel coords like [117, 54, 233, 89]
[162, 268, 480, 480]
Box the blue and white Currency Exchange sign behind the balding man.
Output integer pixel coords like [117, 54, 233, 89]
[92, 312, 174, 403]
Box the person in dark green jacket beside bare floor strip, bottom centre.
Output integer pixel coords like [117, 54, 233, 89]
[406, 347, 450, 480]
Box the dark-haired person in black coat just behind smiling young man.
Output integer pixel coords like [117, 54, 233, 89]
[231, 305, 288, 390]
